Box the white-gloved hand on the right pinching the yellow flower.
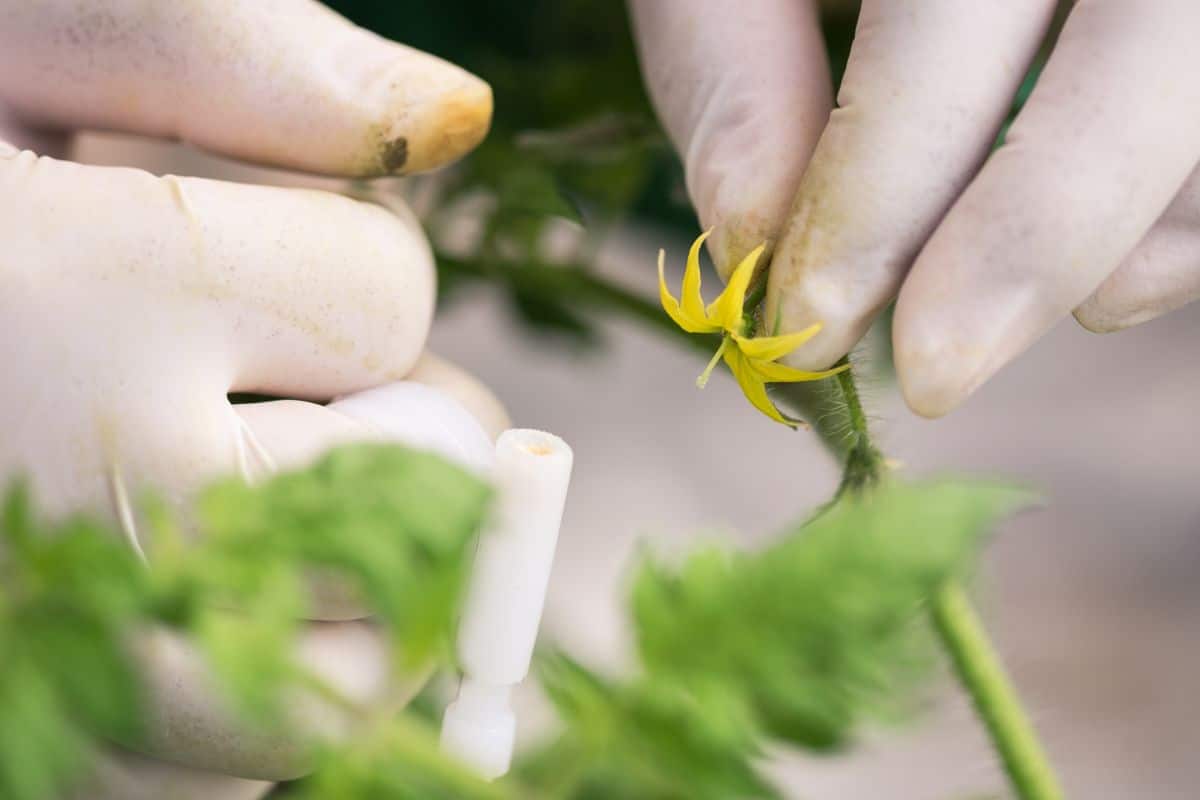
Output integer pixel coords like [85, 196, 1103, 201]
[630, 0, 1200, 416]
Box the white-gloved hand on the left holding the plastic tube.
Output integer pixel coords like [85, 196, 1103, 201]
[0, 0, 506, 800]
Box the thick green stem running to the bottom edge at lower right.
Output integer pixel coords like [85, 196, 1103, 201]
[931, 582, 1063, 800]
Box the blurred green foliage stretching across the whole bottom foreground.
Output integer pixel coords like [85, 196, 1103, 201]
[0, 445, 1024, 800]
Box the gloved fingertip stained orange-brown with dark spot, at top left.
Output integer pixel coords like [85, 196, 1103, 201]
[0, 0, 492, 176]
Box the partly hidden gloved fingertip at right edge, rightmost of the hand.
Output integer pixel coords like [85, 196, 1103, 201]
[1075, 165, 1200, 333]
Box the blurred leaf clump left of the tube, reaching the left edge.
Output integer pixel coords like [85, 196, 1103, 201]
[0, 445, 490, 800]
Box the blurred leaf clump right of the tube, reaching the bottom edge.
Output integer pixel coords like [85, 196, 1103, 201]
[511, 481, 1030, 800]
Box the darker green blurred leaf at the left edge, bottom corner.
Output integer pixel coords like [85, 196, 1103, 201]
[0, 483, 146, 800]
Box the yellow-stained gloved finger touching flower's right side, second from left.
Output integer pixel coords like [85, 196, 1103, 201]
[764, 0, 1055, 369]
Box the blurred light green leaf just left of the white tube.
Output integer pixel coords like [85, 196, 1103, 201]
[189, 445, 490, 666]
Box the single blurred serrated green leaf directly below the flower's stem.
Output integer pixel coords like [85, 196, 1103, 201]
[632, 482, 1030, 748]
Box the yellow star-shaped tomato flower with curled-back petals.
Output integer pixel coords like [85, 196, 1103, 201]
[659, 231, 846, 428]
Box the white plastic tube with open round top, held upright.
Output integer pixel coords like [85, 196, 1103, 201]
[442, 428, 574, 778]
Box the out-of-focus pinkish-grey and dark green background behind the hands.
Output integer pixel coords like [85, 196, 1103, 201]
[77, 0, 1200, 800]
